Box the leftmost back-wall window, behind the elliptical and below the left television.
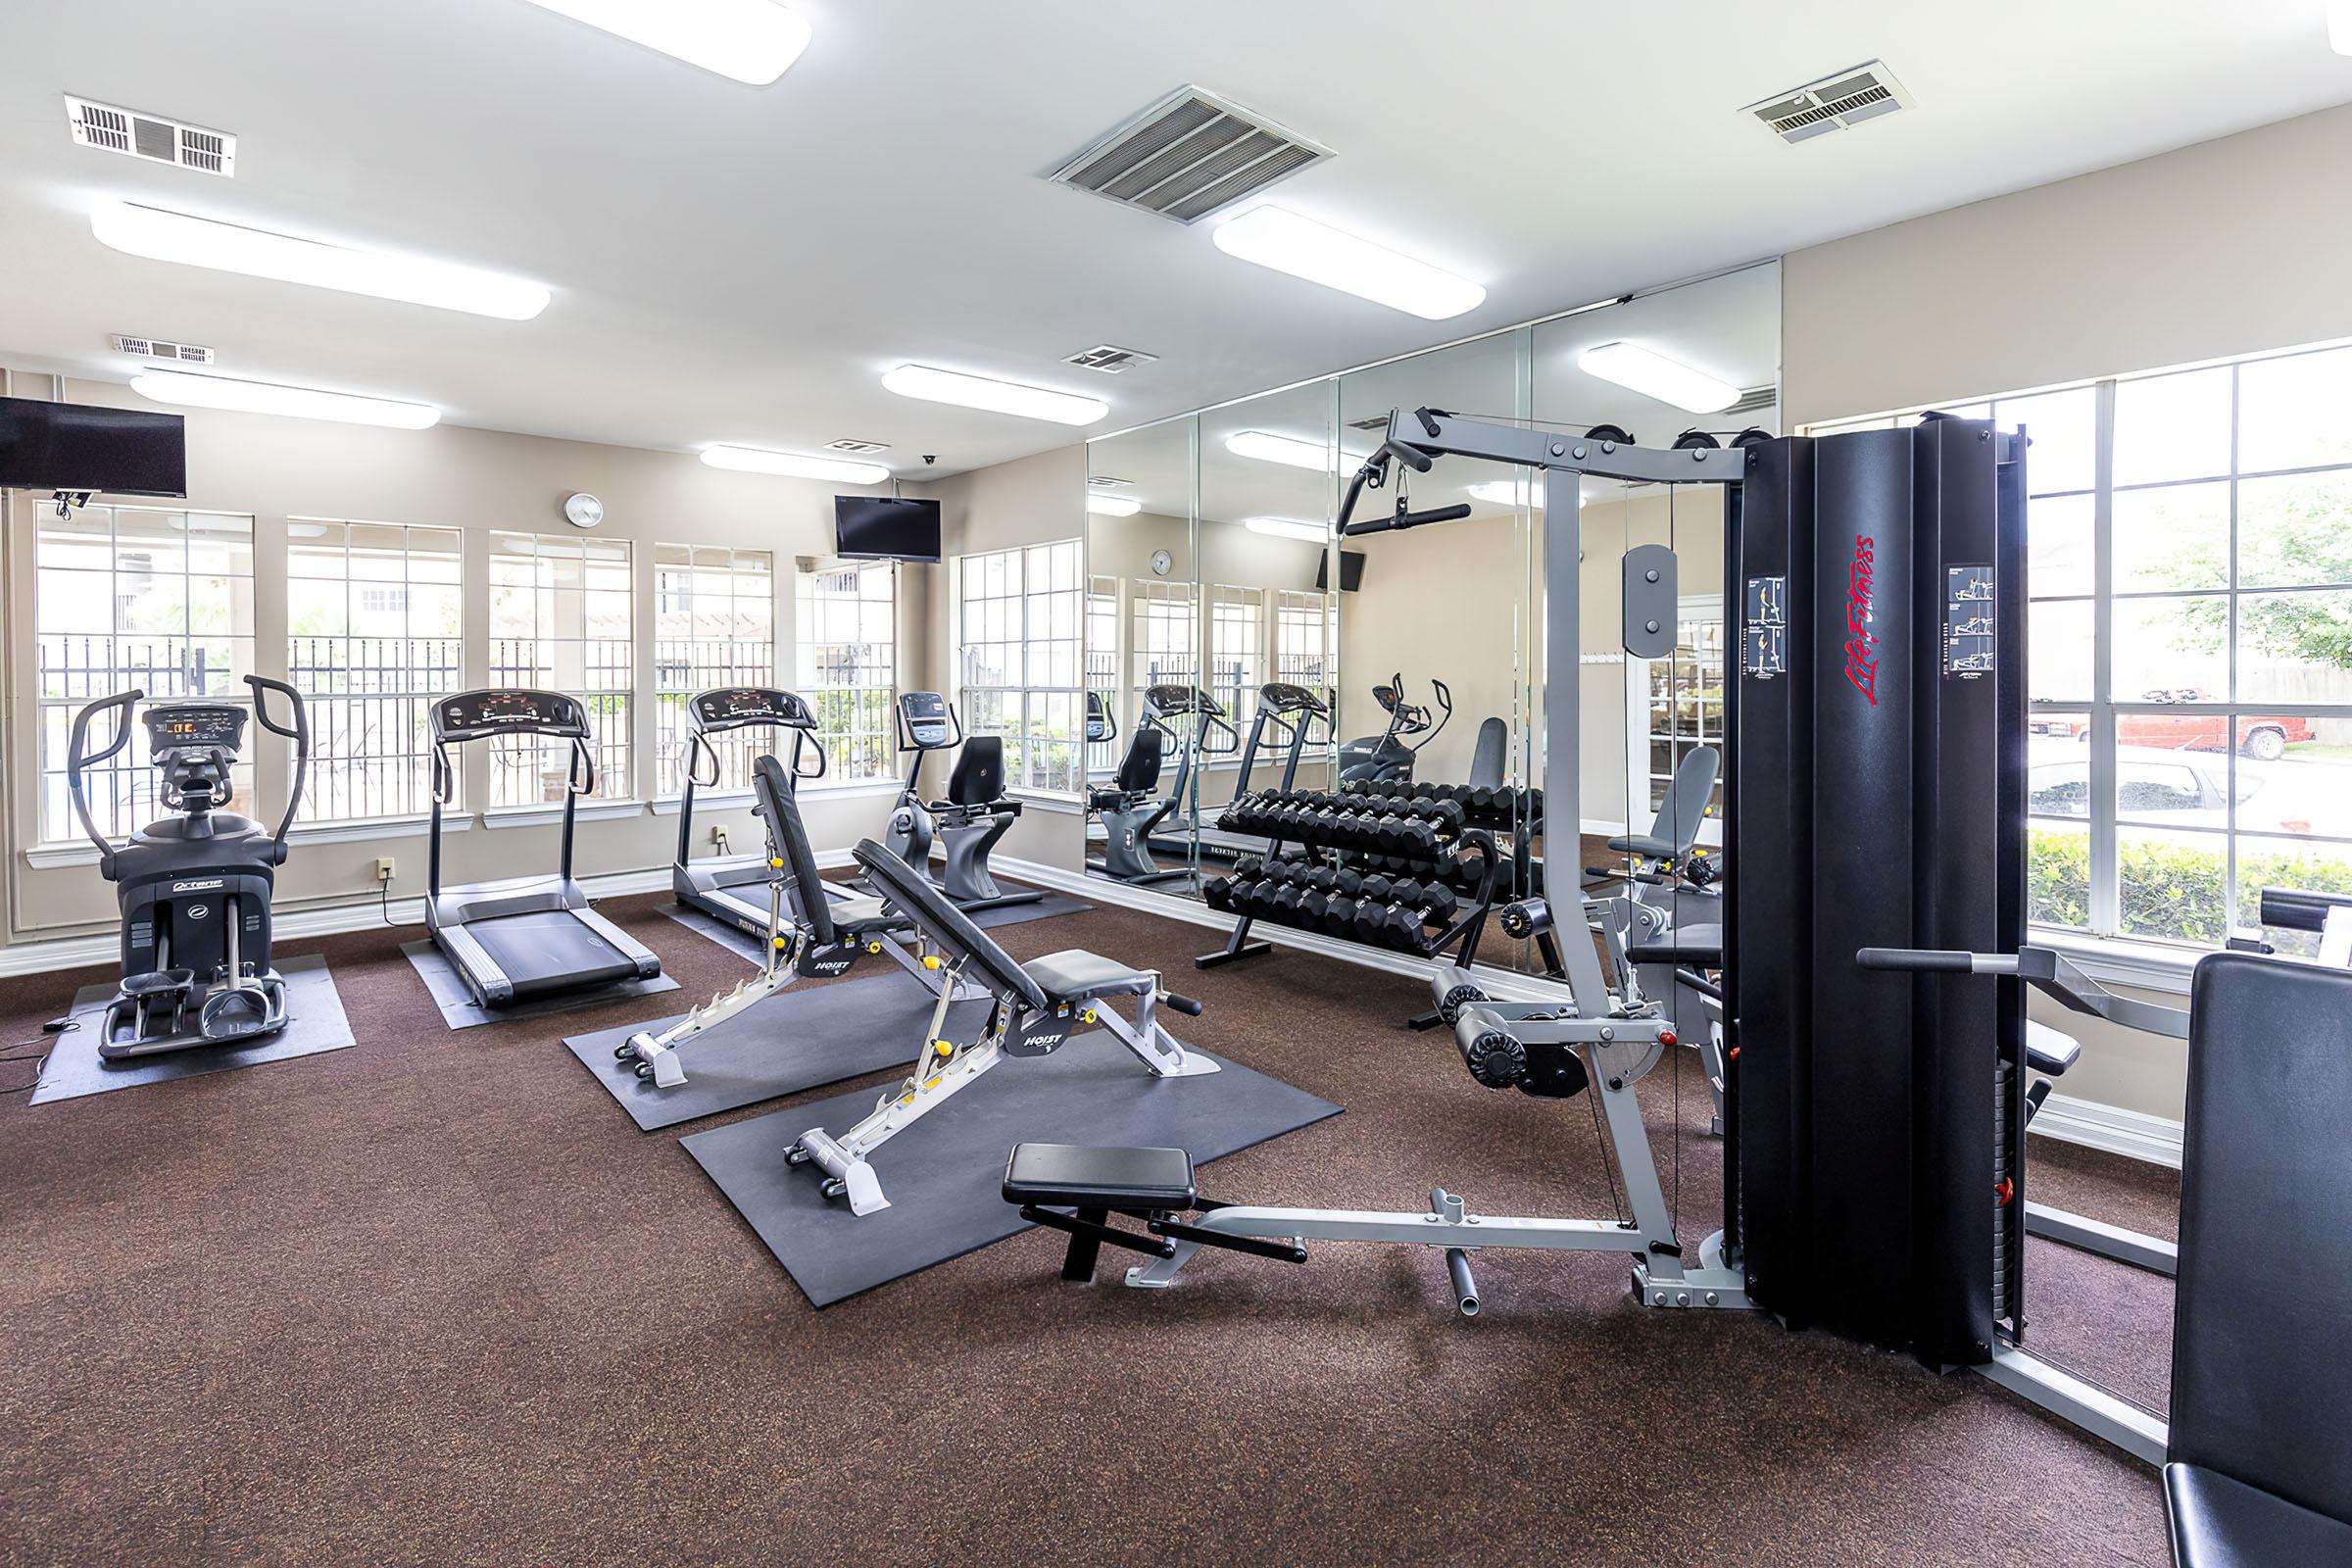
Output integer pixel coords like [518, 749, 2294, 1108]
[33, 503, 269, 849]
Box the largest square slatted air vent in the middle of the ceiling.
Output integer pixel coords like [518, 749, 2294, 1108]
[1047, 87, 1331, 223]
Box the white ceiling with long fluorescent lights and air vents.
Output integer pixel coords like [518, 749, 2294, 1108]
[0, 0, 2352, 472]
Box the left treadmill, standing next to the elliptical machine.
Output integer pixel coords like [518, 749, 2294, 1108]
[425, 686, 661, 1006]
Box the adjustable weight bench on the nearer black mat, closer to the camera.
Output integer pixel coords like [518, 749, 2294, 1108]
[788, 839, 1218, 1215]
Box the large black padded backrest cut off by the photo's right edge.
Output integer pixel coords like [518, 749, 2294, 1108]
[2166, 953, 2352, 1523]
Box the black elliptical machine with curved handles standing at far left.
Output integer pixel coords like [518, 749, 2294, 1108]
[66, 674, 311, 1062]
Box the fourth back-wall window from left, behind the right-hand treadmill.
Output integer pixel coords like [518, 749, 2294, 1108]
[654, 546, 776, 795]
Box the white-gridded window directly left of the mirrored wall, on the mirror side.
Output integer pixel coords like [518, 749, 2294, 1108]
[955, 538, 1084, 795]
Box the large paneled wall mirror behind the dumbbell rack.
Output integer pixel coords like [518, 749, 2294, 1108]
[1084, 264, 1781, 982]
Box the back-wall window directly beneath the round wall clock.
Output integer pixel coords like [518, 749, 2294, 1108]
[489, 534, 635, 807]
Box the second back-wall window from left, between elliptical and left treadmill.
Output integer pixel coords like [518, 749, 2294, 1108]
[284, 517, 466, 827]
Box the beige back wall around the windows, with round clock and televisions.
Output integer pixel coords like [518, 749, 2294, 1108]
[0, 371, 934, 943]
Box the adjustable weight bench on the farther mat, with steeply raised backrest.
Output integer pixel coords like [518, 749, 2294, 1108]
[612, 755, 981, 1089]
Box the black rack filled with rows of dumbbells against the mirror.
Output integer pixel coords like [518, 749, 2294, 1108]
[1193, 790, 1503, 1030]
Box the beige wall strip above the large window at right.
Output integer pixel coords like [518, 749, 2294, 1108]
[1781, 106, 2352, 425]
